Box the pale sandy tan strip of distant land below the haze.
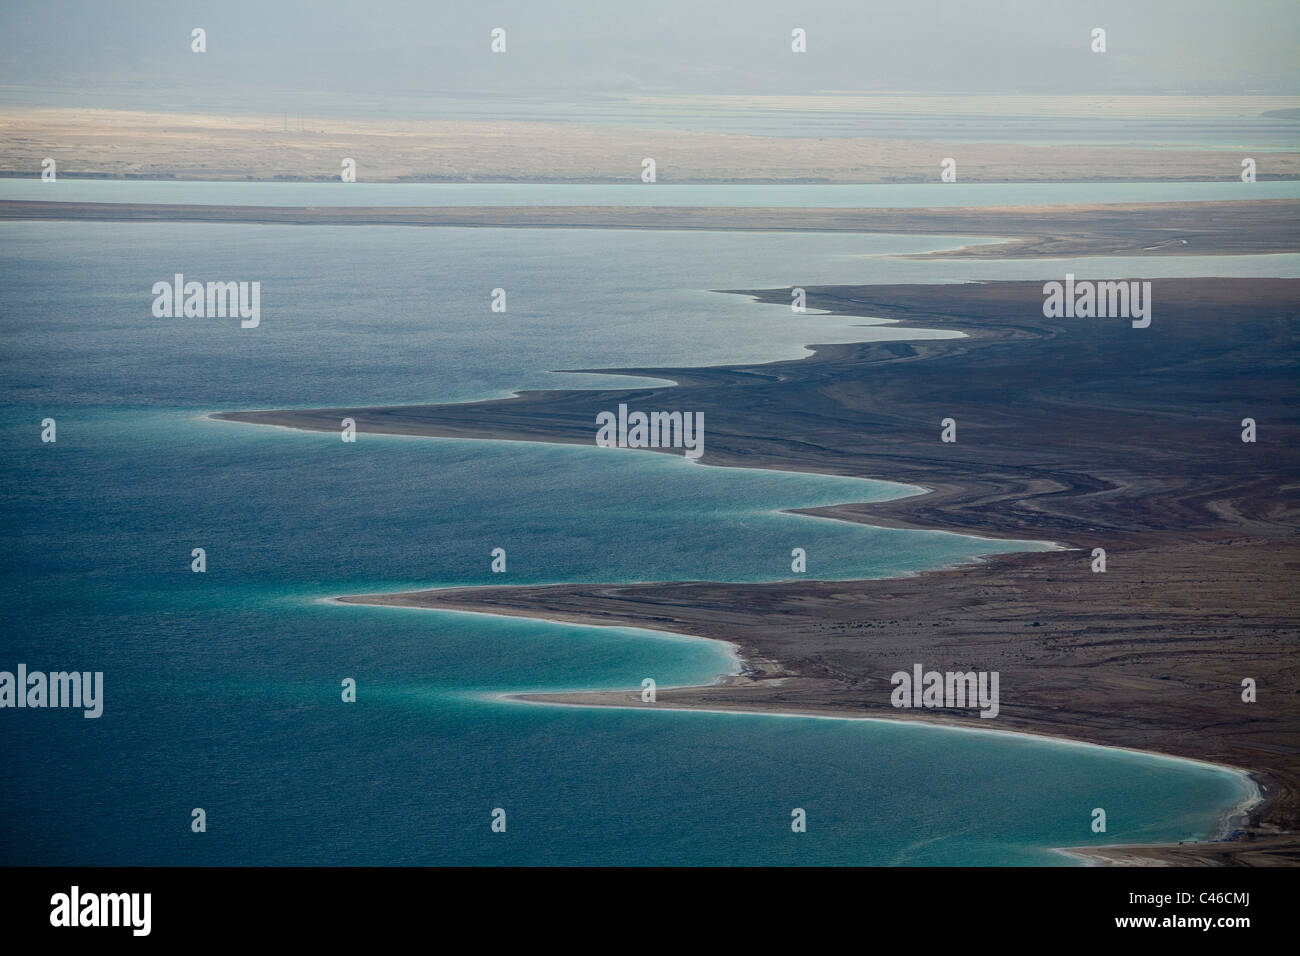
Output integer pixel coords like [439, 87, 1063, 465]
[0, 106, 1300, 183]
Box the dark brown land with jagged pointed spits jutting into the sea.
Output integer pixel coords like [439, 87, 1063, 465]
[220, 278, 1300, 864]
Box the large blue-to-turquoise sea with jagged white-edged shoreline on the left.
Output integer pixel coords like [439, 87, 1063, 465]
[0, 210, 1263, 864]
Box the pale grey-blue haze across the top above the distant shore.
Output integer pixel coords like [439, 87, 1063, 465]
[0, 0, 1300, 109]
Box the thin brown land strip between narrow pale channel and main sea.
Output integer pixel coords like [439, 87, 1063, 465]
[0, 197, 1300, 259]
